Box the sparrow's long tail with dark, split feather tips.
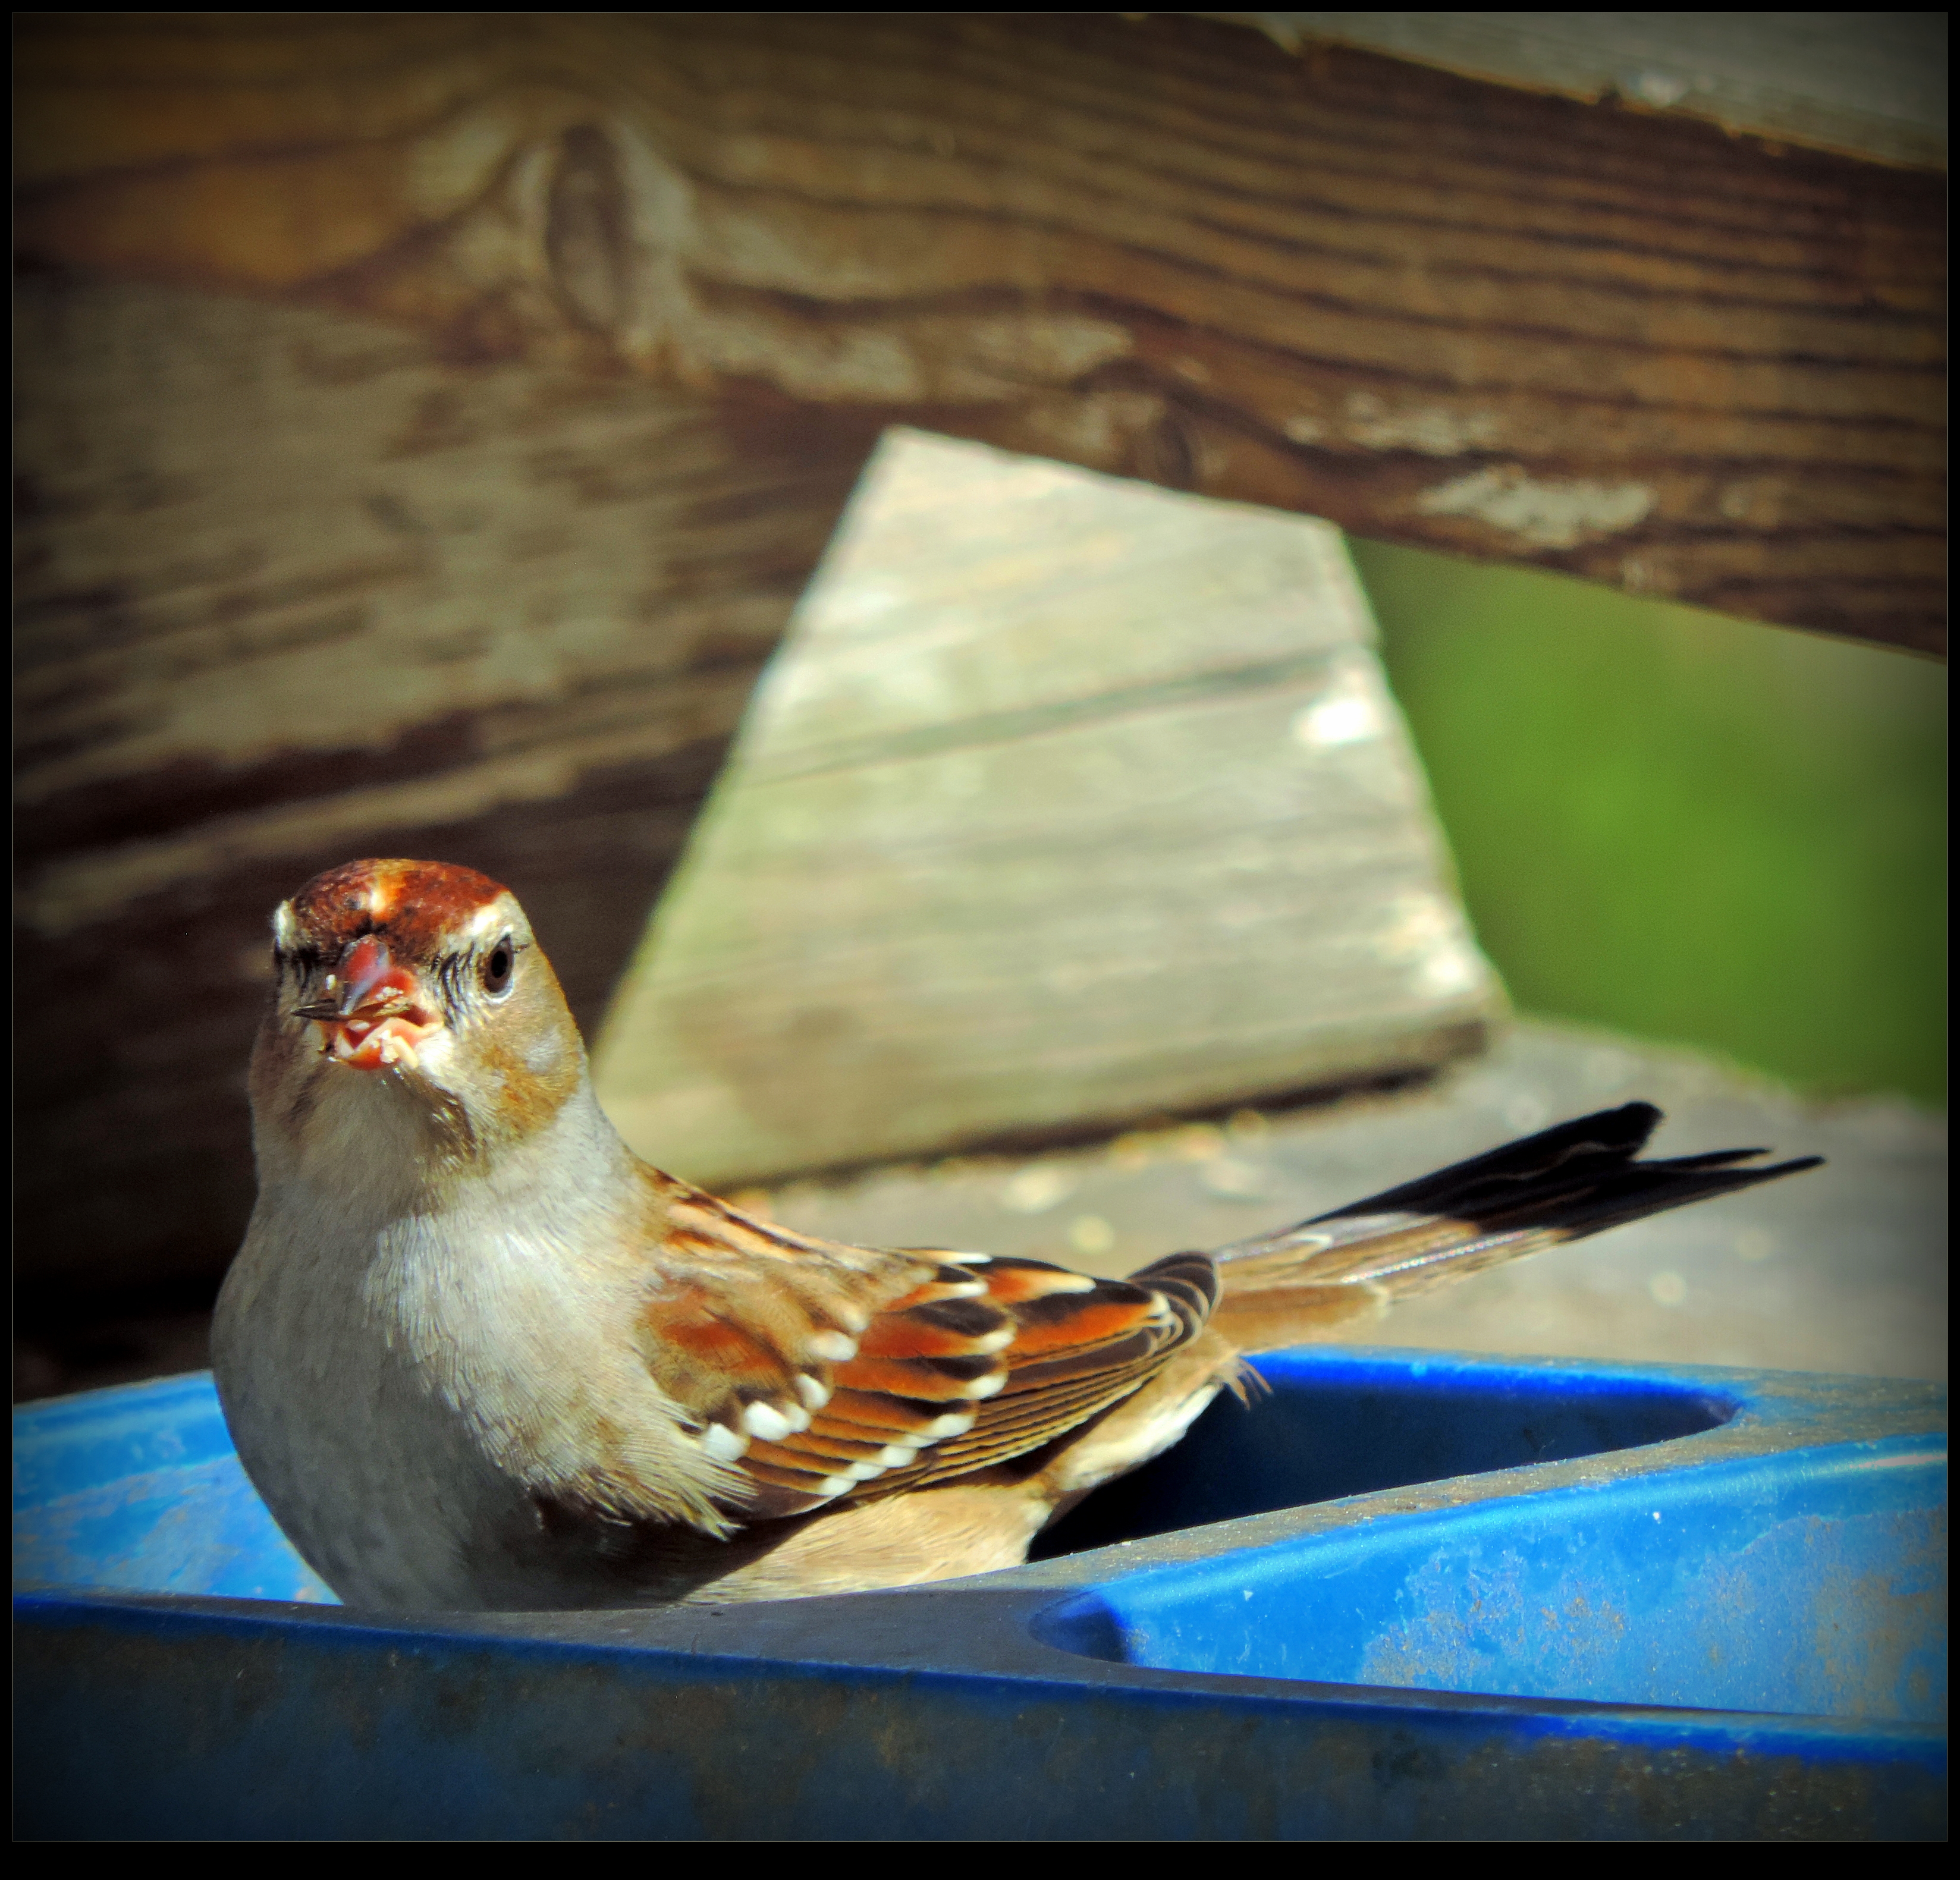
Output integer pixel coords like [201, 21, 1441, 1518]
[1213, 1104, 1821, 1351]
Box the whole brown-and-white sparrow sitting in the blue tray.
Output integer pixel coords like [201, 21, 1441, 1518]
[212, 860, 1817, 1611]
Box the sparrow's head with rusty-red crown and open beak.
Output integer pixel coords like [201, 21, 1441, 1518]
[253, 860, 584, 1162]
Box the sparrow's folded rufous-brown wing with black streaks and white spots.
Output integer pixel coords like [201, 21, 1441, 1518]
[643, 1182, 1217, 1519]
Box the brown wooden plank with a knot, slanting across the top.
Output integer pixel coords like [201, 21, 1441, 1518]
[15, 14, 1945, 651]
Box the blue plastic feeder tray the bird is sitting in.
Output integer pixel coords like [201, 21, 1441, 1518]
[14, 1347, 1946, 1839]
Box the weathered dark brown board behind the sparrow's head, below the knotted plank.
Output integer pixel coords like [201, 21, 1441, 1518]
[14, 278, 872, 1313]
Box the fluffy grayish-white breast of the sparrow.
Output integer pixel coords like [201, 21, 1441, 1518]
[213, 1190, 733, 1608]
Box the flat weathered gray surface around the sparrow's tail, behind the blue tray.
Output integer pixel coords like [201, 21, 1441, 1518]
[760, 1023, 1946, 1378]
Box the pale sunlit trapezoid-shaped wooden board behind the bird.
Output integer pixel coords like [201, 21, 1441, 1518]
[598, 431, 1502, 1182]
